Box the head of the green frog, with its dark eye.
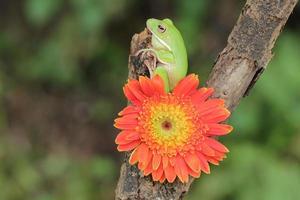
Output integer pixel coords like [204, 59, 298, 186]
[146, 18, 181, 51]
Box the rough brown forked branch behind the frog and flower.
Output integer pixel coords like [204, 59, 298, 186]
[116, 0, 297, 200]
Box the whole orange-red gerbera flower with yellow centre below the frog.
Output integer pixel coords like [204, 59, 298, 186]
[115, 74, 232, 183]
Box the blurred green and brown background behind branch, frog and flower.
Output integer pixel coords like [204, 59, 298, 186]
[0, 0, 300, 200]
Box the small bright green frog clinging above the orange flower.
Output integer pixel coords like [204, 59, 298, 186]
[142, 19, 188, 92]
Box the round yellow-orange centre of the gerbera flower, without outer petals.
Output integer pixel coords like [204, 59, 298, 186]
[138, 94, 202, 156]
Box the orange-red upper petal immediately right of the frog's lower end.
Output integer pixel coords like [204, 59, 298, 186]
[173, 74, 199, 96]
